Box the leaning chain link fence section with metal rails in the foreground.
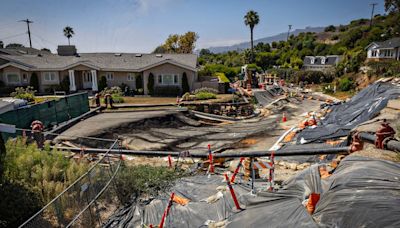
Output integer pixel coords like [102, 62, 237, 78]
[20, 140, 122, 227]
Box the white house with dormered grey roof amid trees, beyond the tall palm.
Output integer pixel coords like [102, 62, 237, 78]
[302, 55, 341, 72]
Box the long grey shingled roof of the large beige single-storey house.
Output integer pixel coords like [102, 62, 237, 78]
[0, 53, 197, 71]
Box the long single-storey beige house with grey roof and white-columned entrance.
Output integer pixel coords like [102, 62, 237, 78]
[0, 46, 197, 94]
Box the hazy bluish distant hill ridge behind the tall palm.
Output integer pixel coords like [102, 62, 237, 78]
[208, 27, 325, 53]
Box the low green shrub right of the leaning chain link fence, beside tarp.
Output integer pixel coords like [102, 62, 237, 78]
[115, 165, 183, 204]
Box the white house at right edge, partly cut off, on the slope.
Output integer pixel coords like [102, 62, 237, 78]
[365, 37, 400, 61]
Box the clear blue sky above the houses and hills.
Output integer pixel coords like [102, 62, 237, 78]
[0, 0, 385, 53]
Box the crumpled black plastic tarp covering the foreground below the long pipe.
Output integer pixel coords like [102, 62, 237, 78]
[105, 156, 400, 228]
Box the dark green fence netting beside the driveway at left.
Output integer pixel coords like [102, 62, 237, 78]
[0, 92, 89, 135]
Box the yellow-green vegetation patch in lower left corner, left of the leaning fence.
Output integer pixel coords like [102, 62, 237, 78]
[0, 138, 88, 227]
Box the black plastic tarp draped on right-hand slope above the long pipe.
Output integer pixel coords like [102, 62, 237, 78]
[297, 82, 400, 143]
